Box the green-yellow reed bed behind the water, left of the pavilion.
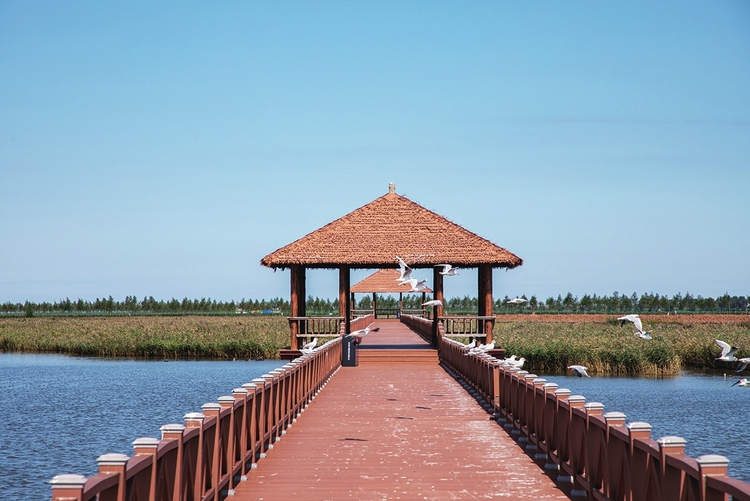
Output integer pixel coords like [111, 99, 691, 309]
[0, 316, 289, 360]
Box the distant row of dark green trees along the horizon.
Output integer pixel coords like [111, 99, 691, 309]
[0, 292, 750, 316]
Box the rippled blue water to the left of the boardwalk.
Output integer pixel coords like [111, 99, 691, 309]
[0, 353, 283, 500]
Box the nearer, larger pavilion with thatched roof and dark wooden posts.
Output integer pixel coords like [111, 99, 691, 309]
[260, 183, 523, 350]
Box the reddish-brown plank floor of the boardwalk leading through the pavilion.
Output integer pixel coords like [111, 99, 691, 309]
[235, 321, 568, 501]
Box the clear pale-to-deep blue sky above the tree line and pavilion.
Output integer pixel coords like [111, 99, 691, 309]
[0, 0, 750, 302]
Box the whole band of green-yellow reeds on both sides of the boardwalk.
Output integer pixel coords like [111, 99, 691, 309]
[0, 315, 750, 375]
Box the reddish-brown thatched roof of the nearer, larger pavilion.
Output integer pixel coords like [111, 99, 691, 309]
[260, 187, 523, 268]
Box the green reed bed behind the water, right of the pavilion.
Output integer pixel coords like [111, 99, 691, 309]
[494, 315, 750, 376]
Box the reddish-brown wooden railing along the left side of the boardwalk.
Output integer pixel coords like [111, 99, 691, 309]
[50, 338, 341, 501]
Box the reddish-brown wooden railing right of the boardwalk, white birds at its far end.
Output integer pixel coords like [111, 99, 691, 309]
[439, 327, 750, 501]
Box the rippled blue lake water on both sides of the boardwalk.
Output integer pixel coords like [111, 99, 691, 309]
[0, 353, 750, 500]
